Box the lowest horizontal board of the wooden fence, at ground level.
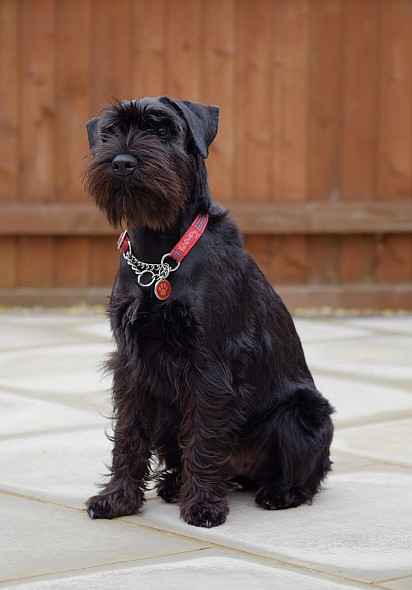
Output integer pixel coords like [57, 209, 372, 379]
[0, 283, 412, 313]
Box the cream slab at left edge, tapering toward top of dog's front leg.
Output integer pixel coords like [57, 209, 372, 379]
[0, 392, 102, 437]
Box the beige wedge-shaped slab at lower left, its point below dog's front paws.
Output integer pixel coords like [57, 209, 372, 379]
[0, 494, 203, 581]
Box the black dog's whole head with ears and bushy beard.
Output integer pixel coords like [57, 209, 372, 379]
[84, 96, 219, 230]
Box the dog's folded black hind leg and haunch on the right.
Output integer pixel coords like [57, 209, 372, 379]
[256, 388, 333, 510]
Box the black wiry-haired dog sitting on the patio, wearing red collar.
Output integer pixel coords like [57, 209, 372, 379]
[85, 96, 333, 527]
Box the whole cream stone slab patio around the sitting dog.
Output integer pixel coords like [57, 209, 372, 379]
[0, 313, 412, 590]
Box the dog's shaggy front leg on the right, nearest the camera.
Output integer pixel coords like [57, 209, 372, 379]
[179, 371, 236, 528]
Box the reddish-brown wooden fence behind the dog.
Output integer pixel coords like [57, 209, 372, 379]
[0, 0, 412, 308]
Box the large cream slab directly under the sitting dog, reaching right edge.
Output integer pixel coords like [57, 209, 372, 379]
[127, 468, 412, 582]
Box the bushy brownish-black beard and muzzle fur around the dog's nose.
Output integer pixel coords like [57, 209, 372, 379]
[84, 132, 194, 231]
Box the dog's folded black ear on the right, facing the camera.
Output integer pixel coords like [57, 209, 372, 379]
[165, 97, 219, 159]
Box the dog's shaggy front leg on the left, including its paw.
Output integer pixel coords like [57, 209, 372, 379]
[86, 366, 150, 519]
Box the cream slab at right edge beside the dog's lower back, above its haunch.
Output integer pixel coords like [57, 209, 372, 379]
[305, 335, 412, 383]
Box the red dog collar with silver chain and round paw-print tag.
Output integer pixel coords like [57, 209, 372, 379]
[117, 213, 209, 300]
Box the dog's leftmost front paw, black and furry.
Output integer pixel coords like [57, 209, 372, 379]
[86, 490, 143, 519]
